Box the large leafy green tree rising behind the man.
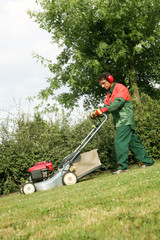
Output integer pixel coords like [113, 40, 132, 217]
[29, 0, 160, 107]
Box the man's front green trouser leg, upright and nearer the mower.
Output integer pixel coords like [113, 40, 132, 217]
[115, 126, 132, 169]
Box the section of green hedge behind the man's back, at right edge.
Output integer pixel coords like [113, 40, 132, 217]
[134, 94, 160, 160]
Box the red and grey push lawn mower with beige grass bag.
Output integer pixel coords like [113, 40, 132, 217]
[20, 114, 108, 194]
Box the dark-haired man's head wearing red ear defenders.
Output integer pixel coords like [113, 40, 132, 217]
[98, 72, 114, 90]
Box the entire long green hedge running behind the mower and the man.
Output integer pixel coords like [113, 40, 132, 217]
[0, 94, 160, 194]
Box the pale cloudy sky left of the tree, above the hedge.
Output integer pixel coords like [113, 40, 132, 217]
[0, 0, 59, 119]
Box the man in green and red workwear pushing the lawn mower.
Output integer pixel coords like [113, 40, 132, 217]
[90, 72, 153, 174]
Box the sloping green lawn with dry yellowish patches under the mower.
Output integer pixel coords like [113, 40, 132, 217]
[0, 162, 160, 240]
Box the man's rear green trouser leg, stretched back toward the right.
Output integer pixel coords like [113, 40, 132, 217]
[129, 130, 153, 166]
